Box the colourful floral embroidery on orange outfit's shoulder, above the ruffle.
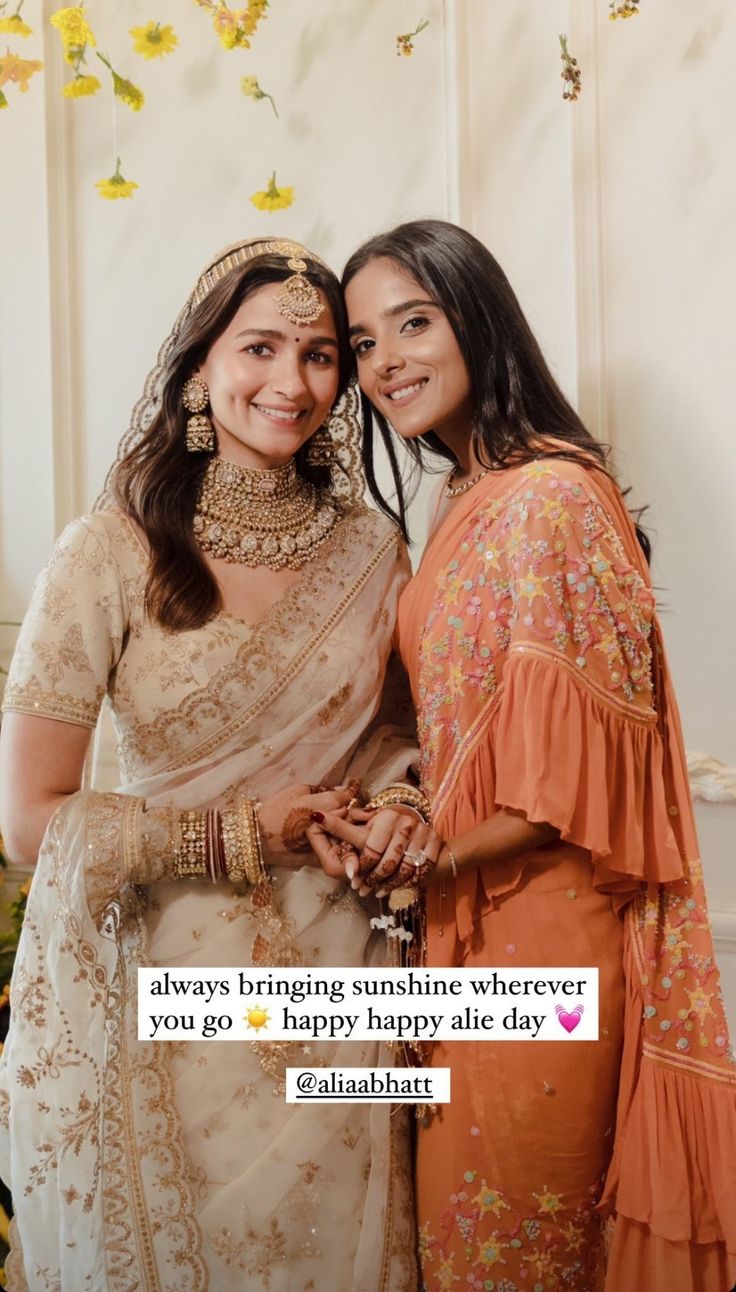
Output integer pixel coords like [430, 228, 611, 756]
[418, 459, 655, 793]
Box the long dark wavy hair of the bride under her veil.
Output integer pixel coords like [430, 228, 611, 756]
[110, 256, 354, 630]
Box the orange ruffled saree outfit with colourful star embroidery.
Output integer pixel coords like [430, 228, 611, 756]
[399, 457, 736, 1292]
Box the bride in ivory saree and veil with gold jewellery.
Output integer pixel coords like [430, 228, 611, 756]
[0, 239, 416, 1292]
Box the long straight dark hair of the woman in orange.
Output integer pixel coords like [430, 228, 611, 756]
[342, 220, 651, 561]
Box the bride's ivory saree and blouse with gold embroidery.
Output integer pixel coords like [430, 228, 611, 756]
[1, 506, 416, 1292]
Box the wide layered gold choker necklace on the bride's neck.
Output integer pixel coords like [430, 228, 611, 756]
[194, 457, 338, 570]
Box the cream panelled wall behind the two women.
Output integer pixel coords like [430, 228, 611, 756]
[0, 0, 736, 1016]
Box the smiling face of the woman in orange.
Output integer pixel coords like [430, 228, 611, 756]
[345, 257, 473, 447]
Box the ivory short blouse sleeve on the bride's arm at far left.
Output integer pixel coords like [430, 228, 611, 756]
[3, 514, 127, 727]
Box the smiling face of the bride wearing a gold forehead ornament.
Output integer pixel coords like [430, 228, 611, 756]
[199, 283, 338, 468]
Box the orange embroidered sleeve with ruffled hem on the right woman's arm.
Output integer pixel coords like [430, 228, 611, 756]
[492, 459, 683, 888]
